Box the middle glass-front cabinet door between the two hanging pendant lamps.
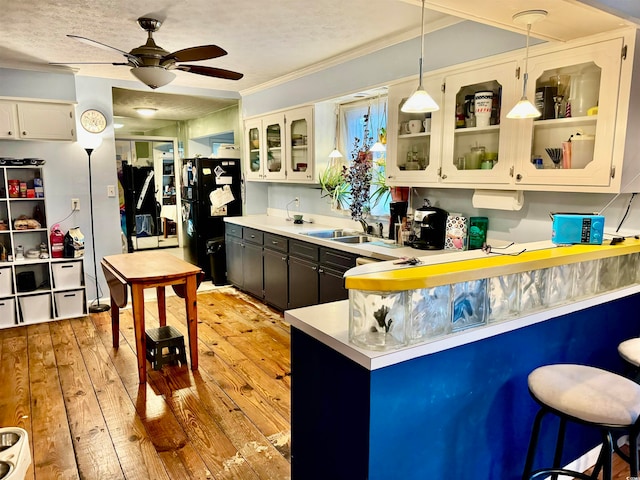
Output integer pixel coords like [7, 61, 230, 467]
[441, 62, 518, 187]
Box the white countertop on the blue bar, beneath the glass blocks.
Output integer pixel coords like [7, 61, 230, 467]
[284, 285, 640, 371]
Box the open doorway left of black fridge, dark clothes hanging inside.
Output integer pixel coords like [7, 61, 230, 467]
[116, 137, 181, 253]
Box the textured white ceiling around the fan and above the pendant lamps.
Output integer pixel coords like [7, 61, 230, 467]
[0, 0, 635, 133]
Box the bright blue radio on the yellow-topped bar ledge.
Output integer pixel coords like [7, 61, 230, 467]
[551, 213, 604, 245]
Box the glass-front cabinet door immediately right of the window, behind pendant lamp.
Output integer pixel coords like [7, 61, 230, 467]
[386, 77, 442, 186]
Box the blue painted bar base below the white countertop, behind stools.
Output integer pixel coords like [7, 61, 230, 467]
[291, 294, 640, 480]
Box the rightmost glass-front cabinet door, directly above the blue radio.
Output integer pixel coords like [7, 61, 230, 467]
[515, 39, 622, 186]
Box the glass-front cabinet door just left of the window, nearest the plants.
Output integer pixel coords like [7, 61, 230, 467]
[285, 107, 314, 182]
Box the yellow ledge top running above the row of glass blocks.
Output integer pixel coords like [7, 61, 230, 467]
[345, 238, 640, 292]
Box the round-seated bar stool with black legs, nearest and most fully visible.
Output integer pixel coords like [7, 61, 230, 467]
[522, 364, 640, 480]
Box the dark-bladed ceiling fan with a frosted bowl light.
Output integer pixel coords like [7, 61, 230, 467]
[50, 17, 243, 90]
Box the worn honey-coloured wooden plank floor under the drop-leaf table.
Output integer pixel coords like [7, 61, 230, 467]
[0, 287, 628, 480]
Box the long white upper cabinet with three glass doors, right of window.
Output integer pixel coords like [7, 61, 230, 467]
[387, 29, 640, 193]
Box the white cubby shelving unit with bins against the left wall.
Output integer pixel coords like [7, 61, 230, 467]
[0, 165, 87, 328]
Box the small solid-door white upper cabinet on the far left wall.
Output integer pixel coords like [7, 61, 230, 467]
[0, 100, 76, 141]
